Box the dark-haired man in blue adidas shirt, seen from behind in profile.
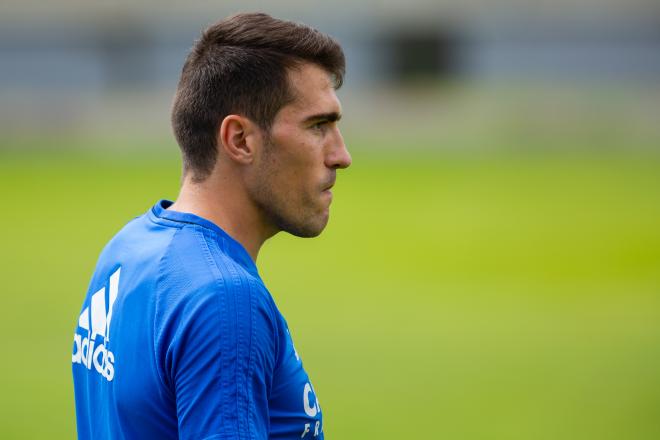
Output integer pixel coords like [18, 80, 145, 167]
[72, 14, 351, 439]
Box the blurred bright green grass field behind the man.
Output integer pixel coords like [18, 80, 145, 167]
[0, 146, 660, 440]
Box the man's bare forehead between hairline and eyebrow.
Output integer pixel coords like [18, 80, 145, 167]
[278, 63, 341, 119]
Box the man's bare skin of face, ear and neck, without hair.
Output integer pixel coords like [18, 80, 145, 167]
[169, 63, 351, 261]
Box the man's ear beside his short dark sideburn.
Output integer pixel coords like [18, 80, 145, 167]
[217, 115, 257, 165]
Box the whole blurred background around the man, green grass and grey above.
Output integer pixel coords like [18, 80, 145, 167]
[0, 0, 660, 440]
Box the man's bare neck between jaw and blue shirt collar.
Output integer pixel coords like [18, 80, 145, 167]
[168, 171, 277, 263]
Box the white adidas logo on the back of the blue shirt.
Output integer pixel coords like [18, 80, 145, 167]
[71, 268, 121, 381]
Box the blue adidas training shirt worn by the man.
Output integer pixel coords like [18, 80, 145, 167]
[72, 201, 323, 440]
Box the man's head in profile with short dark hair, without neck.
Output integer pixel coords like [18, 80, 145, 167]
[172, 14, 351, 237]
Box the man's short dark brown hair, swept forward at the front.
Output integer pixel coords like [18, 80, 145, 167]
[172, 13, 346, 181]
